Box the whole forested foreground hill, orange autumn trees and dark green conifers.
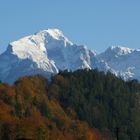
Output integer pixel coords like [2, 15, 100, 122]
[0, 70, 140, 140]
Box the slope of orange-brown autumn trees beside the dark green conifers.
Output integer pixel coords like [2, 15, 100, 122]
[0, 76, 107, 140]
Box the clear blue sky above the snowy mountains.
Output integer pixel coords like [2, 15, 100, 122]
[0, 0, 140, 53]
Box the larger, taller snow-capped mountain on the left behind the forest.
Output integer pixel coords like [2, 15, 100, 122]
[0, 29, 109, 83]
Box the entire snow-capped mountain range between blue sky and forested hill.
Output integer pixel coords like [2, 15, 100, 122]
[0, 29, 140, 84]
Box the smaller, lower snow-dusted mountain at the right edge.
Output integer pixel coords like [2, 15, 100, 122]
[98, 46, 140, 80]
